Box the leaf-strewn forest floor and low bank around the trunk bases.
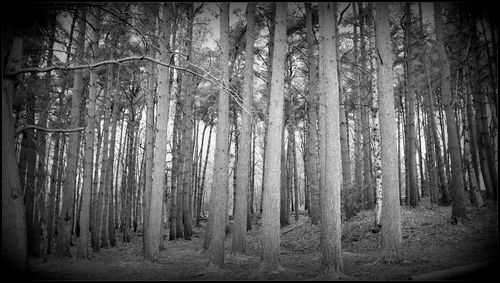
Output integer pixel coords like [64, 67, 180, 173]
[29, 201, 498, 280]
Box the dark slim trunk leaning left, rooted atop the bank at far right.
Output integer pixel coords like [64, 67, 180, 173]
[434, 3, 467, 223]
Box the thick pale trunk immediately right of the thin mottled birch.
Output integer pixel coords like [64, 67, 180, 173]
[375, 3, 402, 262]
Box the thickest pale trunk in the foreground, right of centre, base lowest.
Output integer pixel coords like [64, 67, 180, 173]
[319, 2, 343, 277]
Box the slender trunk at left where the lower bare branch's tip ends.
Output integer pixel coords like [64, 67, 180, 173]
[76, 8, 101, 258]
